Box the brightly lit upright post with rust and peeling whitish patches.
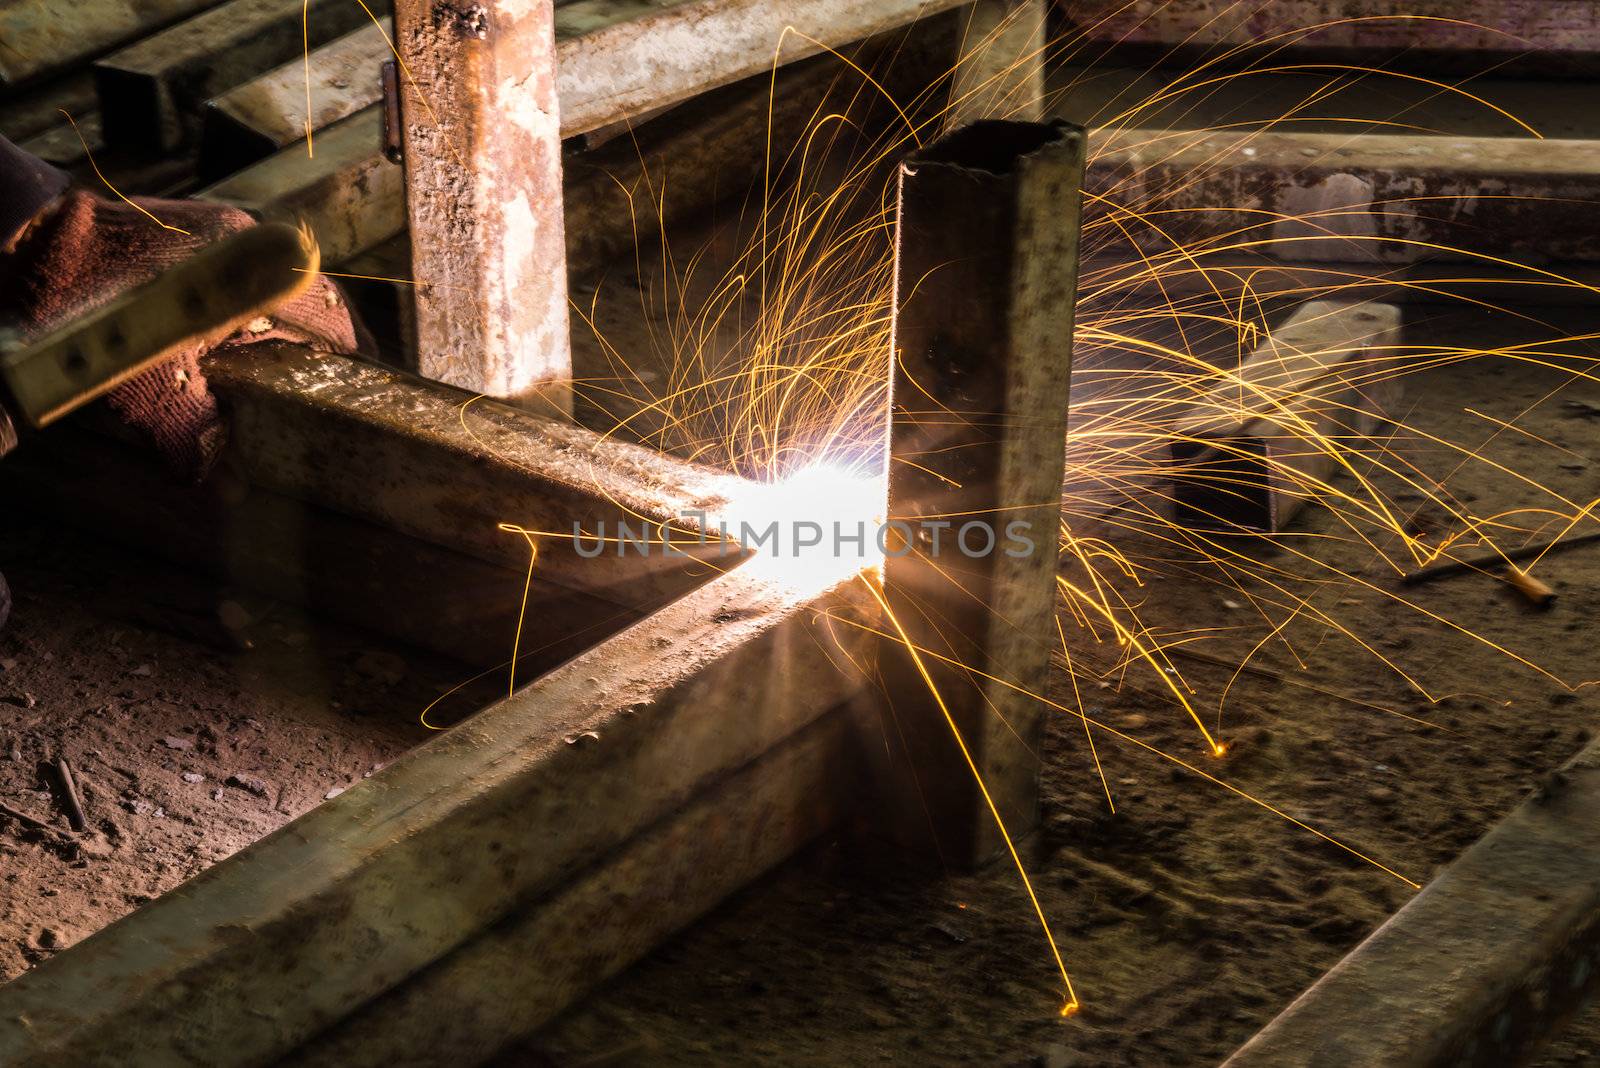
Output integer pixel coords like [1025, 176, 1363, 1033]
[395, 0, 573, 411]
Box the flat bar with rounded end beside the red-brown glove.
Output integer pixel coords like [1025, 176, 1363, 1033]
[0, 222, 320, 456]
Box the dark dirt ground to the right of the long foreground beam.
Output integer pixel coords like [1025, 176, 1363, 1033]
[506, 309, 1600, 1068]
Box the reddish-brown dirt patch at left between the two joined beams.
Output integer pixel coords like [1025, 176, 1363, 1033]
[0, 521, 462, 980]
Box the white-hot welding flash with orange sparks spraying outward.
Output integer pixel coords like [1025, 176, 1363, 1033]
[368, 4, 1597, 1015]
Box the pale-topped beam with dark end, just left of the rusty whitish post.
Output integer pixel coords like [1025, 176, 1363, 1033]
[200, 16, 394, 181]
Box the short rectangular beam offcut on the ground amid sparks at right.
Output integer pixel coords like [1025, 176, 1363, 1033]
[1171, 301, 1400, 532]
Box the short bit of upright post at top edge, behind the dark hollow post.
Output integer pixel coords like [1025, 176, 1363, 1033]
[944, 0, 1048, 131]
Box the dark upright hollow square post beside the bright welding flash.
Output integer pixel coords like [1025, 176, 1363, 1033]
[882, 122, 1085, 865]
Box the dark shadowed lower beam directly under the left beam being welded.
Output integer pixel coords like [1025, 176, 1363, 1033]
[0, 428, 633, 678]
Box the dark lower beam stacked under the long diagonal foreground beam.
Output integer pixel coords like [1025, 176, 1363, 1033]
[283, 710, 859, 1068]
